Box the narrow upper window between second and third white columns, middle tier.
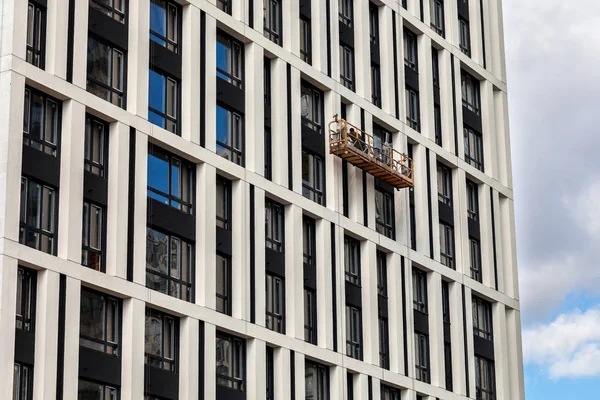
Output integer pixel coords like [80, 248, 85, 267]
[84, 114, 108, 178]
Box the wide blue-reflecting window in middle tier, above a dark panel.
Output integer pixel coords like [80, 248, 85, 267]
[148, 145, 195, 214]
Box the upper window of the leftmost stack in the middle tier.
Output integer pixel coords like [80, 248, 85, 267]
[23, 87, 60, 157]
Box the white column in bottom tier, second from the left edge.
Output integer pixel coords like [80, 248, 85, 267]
[33, 270, 60, 400]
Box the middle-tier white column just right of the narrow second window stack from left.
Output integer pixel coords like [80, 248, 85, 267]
[106, 122, 130, 279]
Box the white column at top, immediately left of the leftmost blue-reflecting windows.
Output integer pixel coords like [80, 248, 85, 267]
[126, 0, 150, 118]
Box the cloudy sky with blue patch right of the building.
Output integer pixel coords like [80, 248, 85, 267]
[503, 0, 600, 400]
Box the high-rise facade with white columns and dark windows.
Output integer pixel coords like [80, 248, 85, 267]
[0, 0, 524, 400]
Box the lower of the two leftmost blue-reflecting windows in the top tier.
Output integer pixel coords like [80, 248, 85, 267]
[148, 67, 179, 134]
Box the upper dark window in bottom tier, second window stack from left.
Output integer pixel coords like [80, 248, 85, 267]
[79, 288, 121, 356]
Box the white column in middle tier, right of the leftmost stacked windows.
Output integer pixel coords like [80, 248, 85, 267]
[58, 100, 85, 264]
